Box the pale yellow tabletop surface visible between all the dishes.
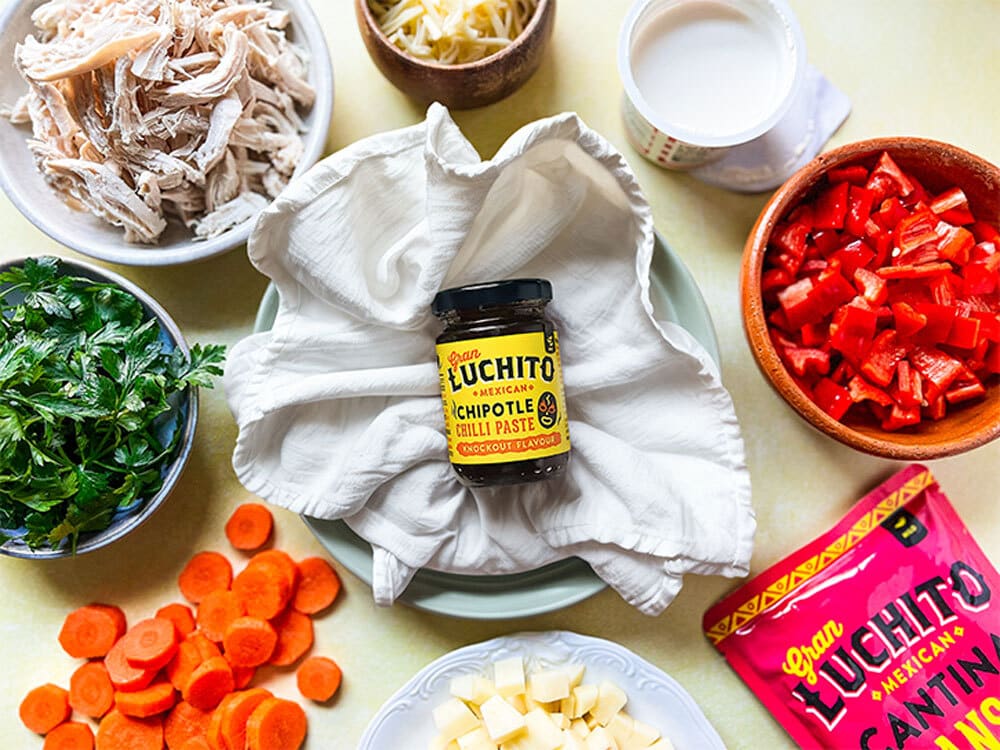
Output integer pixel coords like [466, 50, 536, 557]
[0, 0, 1000, 750]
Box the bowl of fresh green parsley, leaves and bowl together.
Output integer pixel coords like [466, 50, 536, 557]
[0, 257, 224, 558]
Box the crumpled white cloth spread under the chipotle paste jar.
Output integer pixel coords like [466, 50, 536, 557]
[225, 105, 755, 614]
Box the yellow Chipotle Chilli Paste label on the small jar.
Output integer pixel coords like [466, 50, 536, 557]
[437, 332, 569, 464]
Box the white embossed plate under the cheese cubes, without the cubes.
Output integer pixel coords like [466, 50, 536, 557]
[358, 631, 726, 750]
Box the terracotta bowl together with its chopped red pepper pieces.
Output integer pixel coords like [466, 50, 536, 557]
[741, 138, 1000, 460]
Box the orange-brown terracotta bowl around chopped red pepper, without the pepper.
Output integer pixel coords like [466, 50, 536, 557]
[740, 137, 1000, 461]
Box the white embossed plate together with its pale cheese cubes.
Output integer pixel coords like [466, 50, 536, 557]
[358, 631, 725, 750]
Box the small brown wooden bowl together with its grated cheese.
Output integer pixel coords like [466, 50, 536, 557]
[354, 0, 556, 109]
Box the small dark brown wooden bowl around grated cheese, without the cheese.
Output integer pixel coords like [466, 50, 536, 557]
[354, 0, 556, 109]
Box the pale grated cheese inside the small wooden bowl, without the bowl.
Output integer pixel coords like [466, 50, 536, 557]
[369, 0, 538, 65]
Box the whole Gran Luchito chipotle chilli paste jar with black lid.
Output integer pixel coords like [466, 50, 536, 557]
[431, 279, 570, 487]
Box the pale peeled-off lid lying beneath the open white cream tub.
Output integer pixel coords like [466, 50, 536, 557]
[691, 65, 851, 193]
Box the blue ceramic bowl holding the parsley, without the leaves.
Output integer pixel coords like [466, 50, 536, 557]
[0, 258, 198, 559]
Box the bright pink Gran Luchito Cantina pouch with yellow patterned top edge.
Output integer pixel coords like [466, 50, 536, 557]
[703, 465, 1000, 750]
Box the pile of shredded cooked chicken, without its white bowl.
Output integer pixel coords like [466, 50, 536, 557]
[0, 0, 315, 244]
